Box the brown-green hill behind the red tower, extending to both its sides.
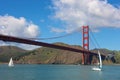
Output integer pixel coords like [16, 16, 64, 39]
[18, 43, 116, 64]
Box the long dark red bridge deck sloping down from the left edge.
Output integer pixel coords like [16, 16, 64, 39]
[0, 34, 105, 56]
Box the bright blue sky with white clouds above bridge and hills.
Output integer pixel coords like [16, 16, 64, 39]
[0, 0, 120, 50]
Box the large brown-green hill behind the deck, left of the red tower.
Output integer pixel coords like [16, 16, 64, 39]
[19, 43, 81, 64]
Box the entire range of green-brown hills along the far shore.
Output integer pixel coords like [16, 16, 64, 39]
[0, 43, 120, 64]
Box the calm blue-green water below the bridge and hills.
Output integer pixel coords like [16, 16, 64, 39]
[0, 64, 120, 80]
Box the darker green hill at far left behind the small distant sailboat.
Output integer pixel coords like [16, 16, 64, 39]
[0, 46, 27, 62]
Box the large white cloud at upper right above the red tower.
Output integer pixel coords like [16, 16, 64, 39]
[53, 0, 120, 31]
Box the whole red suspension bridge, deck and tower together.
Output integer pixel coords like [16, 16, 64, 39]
[0, 26, 105, 64]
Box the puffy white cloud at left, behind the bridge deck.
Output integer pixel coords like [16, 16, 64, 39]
[0, 15, 39, 49]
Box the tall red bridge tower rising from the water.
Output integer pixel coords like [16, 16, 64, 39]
[82, 26, 90, 64]
